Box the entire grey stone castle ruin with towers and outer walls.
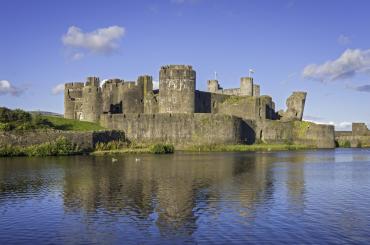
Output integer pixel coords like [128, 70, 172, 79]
[64, 65, 334, 148]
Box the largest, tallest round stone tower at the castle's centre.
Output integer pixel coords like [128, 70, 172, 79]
[159, 65, 196, 113]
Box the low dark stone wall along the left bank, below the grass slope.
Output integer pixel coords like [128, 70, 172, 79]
[0, 129, 125, 151]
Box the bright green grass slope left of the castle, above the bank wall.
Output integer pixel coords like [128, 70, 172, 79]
[41, 116, 104, 131]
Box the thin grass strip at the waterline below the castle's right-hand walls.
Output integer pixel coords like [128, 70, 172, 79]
[182, 144, 310, 152]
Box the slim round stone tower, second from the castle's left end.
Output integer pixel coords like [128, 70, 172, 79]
[81, 77, 102, 122]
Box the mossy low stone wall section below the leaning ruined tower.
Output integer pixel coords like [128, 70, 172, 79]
[253, 120, 335, 148]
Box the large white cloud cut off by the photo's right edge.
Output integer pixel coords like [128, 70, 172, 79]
[303, 49, 370, 82]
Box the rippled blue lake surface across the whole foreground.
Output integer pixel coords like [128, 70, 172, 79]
[0, 149, 370, 244]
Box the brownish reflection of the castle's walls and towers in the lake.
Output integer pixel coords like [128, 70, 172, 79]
[57, 154, 272, 234]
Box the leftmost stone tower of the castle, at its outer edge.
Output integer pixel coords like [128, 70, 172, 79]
[64, 83, 84, 119]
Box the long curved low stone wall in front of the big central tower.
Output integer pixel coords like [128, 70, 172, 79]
[100, 113, 247, 146]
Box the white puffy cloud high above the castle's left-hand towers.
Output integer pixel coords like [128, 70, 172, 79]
[62, 26, 125, 59]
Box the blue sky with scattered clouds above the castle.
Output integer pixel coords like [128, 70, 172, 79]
[0, 0, 370, 128]
